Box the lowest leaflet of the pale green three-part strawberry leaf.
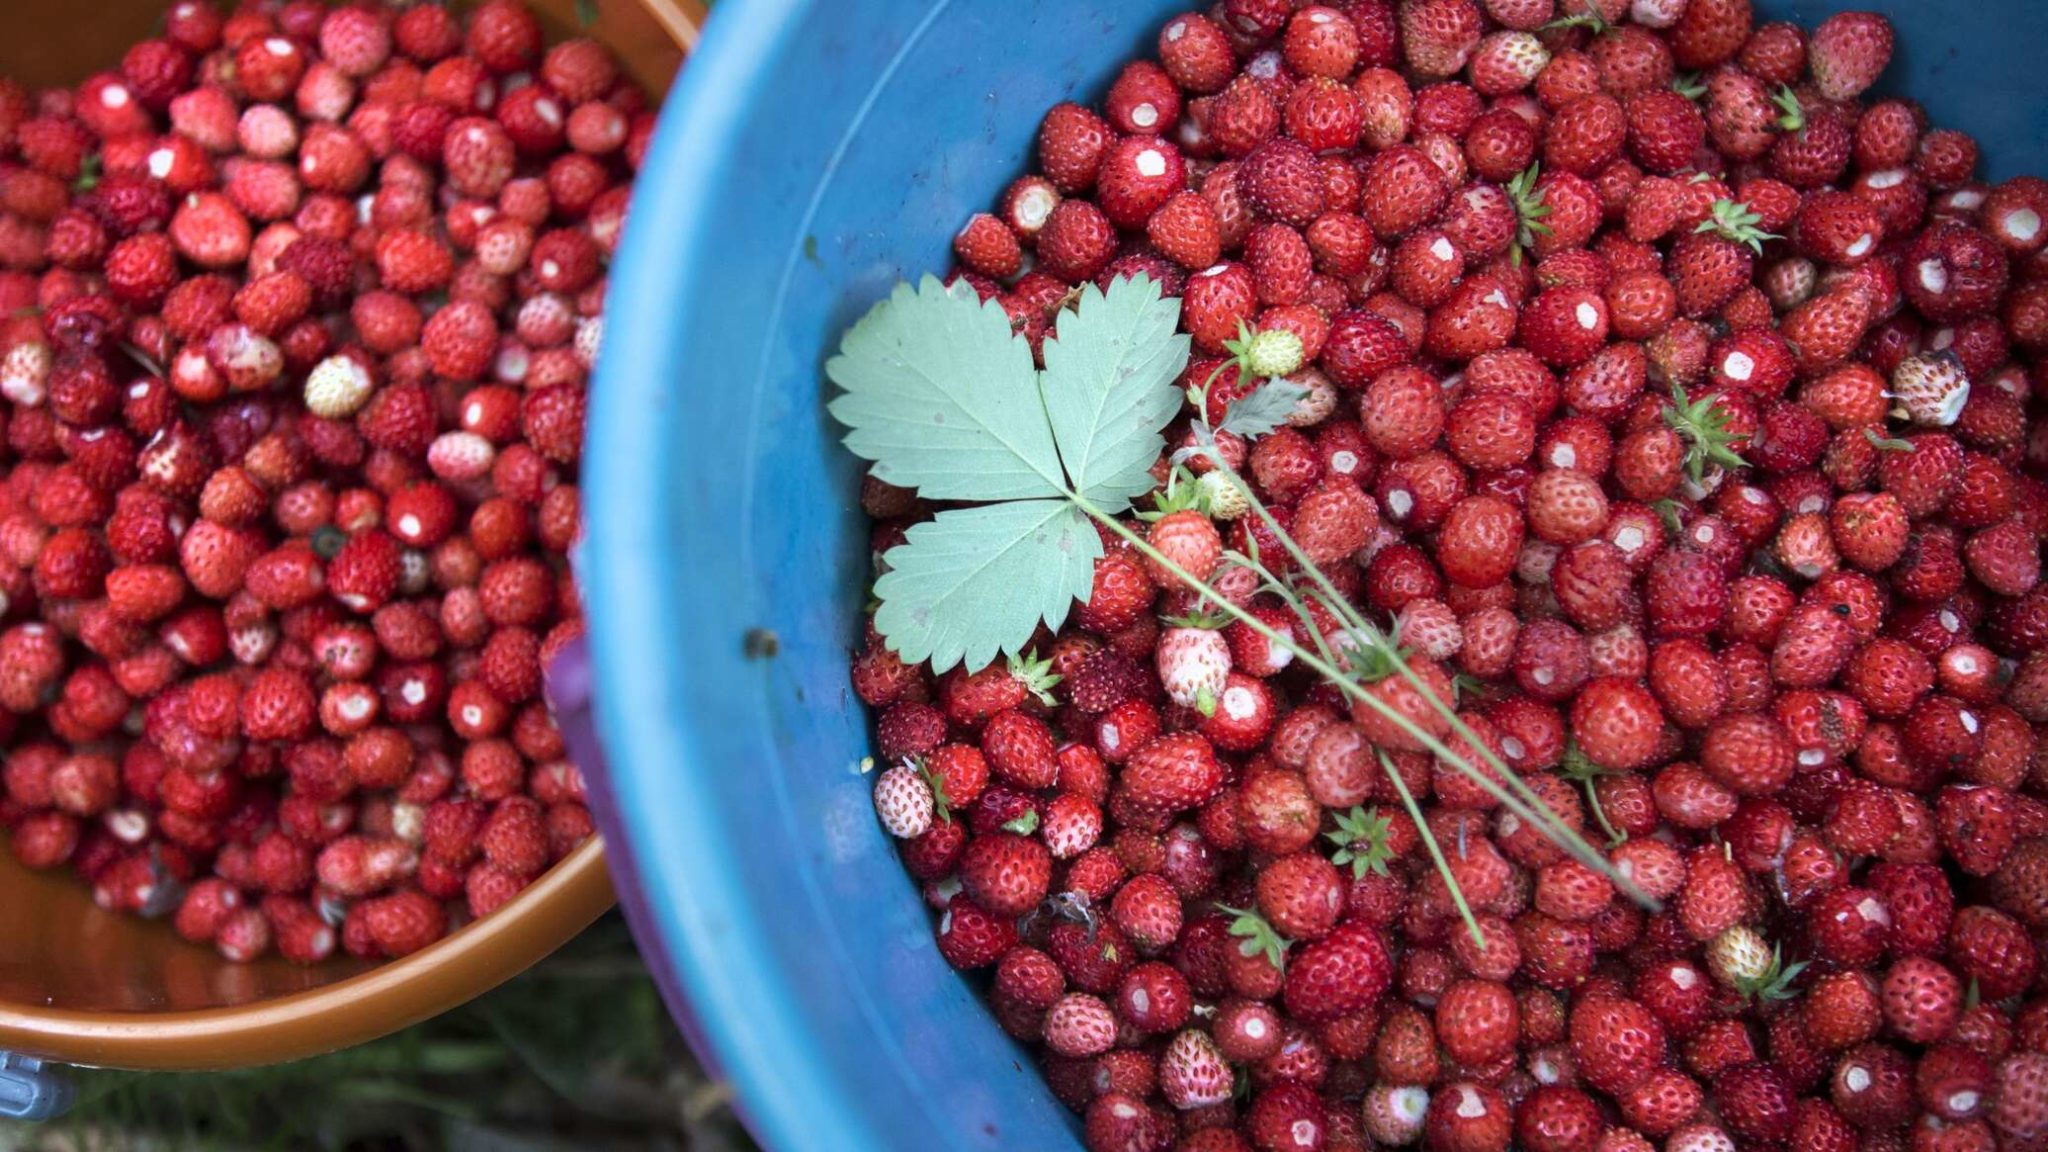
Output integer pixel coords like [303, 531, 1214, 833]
[874, 500, 1102, 672]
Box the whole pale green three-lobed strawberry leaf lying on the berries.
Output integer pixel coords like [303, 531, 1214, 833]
[825, 277, 1188, 672]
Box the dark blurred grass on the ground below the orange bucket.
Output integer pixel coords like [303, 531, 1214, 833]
[0, 916, 754, 1152]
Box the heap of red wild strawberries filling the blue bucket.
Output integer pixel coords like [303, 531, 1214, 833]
[852, 0, 2048, 1152]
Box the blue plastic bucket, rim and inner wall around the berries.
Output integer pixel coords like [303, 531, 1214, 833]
[584, 0, 2048, 1152]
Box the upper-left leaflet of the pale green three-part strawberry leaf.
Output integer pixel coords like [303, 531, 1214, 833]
[825, 277, 1064, 500]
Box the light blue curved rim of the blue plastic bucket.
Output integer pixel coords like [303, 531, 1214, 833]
[578, 0, 860, 1152]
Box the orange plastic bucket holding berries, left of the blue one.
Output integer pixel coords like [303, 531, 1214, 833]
[0, 0, 705, 1068]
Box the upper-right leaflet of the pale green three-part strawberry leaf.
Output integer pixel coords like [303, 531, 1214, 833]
[1048, 277, 1188, 508]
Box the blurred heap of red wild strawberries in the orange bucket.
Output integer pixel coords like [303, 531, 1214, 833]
[0, 0, 651, 963]
